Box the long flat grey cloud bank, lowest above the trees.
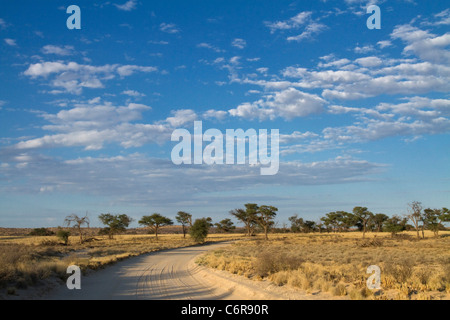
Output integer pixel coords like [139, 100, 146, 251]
[0, 153, 386, 207]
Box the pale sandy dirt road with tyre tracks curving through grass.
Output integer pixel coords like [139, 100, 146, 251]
[42, 243, 248, 300]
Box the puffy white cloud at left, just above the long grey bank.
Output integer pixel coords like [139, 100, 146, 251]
[14, 103, 173, 150]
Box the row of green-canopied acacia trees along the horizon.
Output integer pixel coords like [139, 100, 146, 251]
[44, 201, 450, 243]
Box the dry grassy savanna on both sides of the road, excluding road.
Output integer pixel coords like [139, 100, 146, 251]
[0, 231, 450, 300]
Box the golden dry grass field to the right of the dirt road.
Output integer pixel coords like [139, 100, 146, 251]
[198, 232, 450, 300]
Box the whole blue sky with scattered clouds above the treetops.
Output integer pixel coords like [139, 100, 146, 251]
[0, 0, 450, 227]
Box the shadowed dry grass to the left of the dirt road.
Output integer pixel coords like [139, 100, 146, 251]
[0, 234, 236, 294]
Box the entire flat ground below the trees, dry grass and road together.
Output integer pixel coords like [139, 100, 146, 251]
[0, 231, 450, 300]
